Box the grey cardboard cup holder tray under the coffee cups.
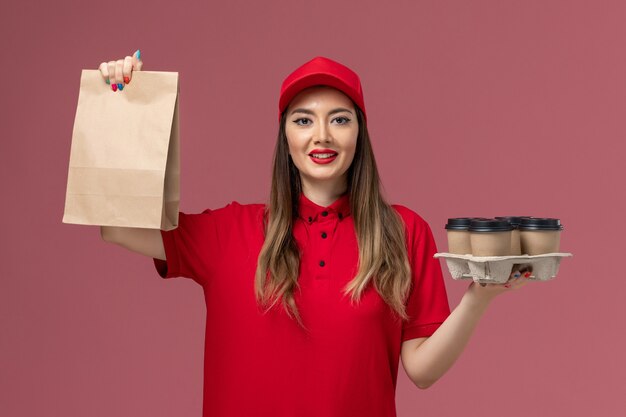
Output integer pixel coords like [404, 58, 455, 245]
[434, 252, 574, 284]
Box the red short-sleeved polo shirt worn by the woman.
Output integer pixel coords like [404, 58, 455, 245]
[154, 194, 450, 417]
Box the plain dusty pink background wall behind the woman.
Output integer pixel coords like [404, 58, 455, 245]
[0, 0, 626, 417]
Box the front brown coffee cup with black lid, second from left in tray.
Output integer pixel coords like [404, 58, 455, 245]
[468, 219, 513, 256]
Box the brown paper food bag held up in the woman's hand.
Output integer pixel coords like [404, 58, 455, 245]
[63, 70, 180, 230]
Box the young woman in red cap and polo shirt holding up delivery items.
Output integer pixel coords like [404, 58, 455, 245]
[100, 51, 525, 417]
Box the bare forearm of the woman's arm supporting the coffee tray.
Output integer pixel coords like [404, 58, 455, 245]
[408, 291, 492, 388]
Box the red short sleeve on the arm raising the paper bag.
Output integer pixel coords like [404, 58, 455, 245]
[153, 208, 227, 285]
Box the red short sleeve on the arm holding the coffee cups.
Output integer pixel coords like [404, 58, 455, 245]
[402, 209, 450, 342]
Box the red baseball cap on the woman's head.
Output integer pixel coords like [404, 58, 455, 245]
[278, 56, 367, 120]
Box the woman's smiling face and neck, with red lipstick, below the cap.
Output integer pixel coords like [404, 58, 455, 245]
[285, 86, 359, 195]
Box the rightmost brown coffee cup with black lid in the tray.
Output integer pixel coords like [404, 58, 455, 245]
[519, 217, 563, 256]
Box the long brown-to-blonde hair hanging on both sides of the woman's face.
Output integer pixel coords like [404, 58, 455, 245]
[255, 105, 411, 329]
